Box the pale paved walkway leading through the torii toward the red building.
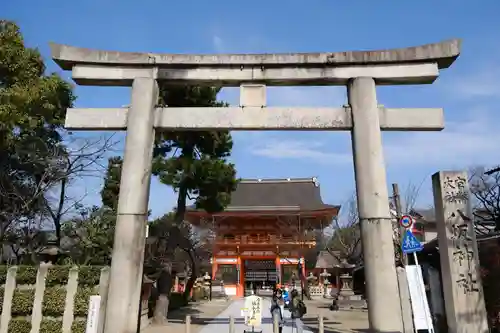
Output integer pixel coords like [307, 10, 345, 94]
[199, 298, 311, 333]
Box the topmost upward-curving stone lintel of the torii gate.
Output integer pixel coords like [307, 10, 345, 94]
[50, 39, 461, 70]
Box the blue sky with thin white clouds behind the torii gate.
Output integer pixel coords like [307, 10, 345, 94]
[0, 0, 500, 216]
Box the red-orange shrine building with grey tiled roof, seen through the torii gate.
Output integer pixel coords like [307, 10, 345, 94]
[186, 178, 340, 296]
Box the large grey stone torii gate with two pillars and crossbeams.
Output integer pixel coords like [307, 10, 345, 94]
[51, 40, 460, 333]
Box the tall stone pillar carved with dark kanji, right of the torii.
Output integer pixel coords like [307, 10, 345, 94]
[432, 171, 488, 333]
